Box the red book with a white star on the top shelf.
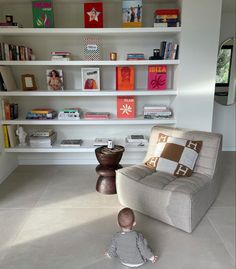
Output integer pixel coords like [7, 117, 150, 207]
[84, 2, 103, 28]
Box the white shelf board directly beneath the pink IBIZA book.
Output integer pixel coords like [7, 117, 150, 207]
[0, 89, 177, 97]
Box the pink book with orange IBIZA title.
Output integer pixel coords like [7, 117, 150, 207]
[147, 65, 167, 90]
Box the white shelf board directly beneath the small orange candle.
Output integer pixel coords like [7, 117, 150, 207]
[0, 60, 179, 66]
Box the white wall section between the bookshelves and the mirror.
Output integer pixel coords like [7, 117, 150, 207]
[176, 0, 221, 131]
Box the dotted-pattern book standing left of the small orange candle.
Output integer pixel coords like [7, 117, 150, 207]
[84, 37, 102, 61]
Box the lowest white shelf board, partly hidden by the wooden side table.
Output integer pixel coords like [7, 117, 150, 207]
[5, 140, 147, 153]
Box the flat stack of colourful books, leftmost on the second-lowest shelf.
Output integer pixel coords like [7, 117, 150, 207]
[26, 108, 57, 120]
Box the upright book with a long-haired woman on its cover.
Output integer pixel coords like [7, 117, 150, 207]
[46, 69, 64, 91]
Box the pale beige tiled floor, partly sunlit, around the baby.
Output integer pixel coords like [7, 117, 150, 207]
[0, 153, 235, 269]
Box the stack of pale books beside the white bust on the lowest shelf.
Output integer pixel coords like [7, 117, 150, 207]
[29, 129, 57, 148]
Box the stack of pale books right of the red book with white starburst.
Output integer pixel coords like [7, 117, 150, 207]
[143, 105, 172, 119]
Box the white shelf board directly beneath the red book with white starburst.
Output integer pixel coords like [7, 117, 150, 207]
[1, 117, 176, 125]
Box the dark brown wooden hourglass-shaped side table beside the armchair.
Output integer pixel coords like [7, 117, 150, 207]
[95, 145, 125, 194]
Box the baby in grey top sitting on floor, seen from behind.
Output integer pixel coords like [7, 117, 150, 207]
[105, 208, 158, 267]
